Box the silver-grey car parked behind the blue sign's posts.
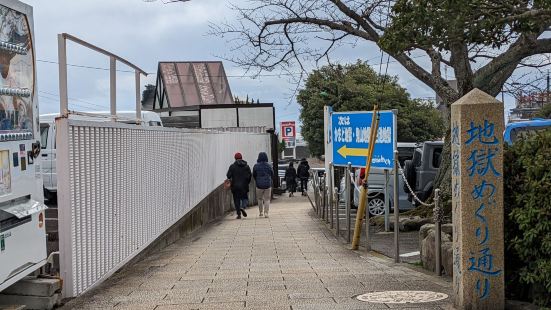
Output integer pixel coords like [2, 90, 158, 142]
[339, 142, 417, 216]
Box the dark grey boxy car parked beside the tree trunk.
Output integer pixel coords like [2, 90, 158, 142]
[403, 141, 444, 201]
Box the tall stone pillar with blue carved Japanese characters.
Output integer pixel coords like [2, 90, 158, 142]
[451, 89, 505, 309]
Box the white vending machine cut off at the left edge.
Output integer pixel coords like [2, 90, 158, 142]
[0, 0, 46, 291]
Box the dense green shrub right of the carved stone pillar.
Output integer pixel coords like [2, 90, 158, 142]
[504, 129, 551, 306]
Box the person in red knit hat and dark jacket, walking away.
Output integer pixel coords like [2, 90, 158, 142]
[226, 153, 251, 219]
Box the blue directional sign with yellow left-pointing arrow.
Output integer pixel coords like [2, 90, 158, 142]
[331, 111, 396, 170]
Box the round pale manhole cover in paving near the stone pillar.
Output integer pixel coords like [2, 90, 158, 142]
[357, 291, 448, 304]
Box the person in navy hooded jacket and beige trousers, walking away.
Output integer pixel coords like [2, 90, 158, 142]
[253, 152, 274, 217]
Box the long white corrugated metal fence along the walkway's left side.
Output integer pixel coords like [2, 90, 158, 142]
[56, 118, 270, 297]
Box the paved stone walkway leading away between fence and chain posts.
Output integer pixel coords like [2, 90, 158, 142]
[65, 197, 451, 310]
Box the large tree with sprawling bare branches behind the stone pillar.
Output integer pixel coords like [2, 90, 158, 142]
[211, 0, 551, 205]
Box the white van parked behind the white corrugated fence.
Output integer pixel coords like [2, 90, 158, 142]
[40, 111, 163, 201]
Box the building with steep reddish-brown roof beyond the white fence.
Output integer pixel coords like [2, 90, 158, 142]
[147, 61, 275, 129]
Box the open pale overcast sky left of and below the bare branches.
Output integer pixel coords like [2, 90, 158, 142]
[24, 0, 516, 128]
